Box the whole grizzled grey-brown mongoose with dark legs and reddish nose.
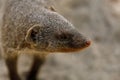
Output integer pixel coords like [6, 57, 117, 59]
[0, 0, 90, 80]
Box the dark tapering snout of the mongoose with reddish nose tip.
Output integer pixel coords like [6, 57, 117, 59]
[53, 29, 91, 52]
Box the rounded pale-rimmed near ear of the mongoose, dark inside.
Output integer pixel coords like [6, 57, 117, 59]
[25, 25, 40, 43]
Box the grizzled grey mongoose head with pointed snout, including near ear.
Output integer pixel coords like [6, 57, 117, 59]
[26, 9, 90, 52]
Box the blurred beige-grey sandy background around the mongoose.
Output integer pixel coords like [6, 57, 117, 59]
[0, 0, 120, 80]
